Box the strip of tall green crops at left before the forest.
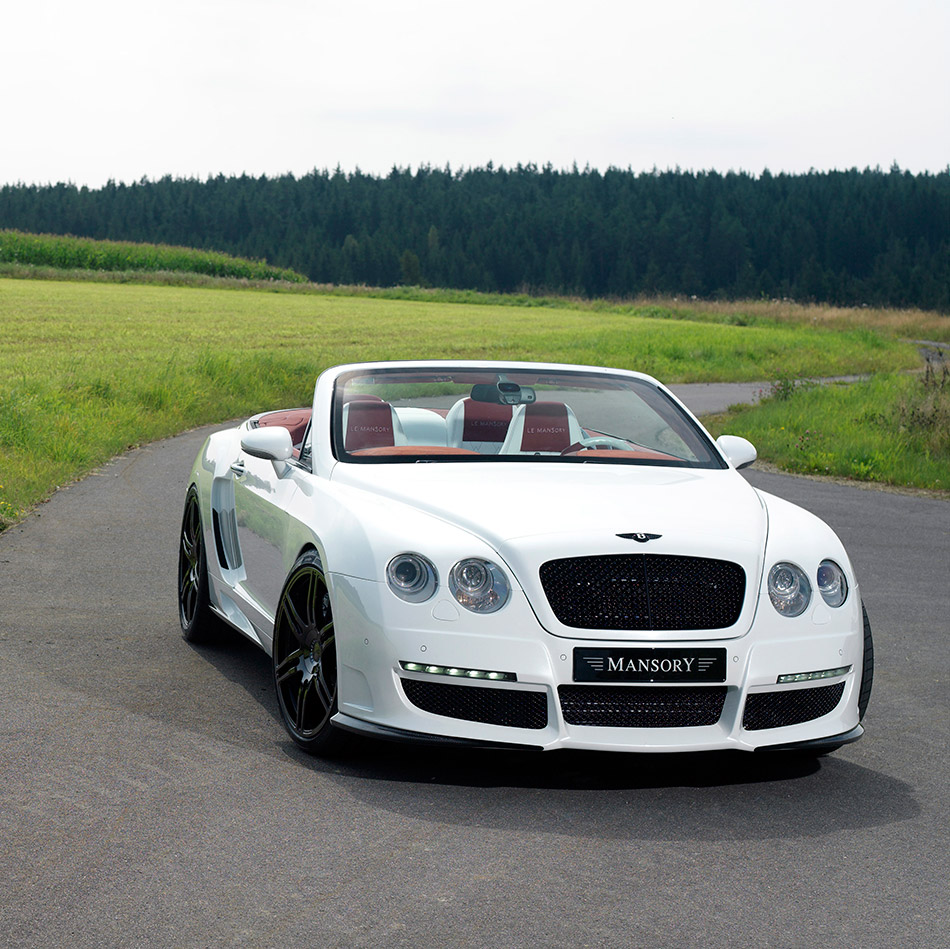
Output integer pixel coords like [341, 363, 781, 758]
[0, 230, 306, 283]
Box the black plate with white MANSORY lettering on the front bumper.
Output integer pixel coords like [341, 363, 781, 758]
[574, 646, 726, 682]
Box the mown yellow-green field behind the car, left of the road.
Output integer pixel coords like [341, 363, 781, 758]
[0, 279, 939, 527]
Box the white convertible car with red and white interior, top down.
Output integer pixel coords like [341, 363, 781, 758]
[178, 362, 873, 754]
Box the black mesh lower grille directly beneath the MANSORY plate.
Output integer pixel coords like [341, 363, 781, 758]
[557, 685, 726, 728]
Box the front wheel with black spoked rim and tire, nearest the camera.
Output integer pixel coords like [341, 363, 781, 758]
[272, 550, 344, 755]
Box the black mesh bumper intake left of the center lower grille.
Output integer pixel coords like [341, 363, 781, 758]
[400, 679, 548, 728]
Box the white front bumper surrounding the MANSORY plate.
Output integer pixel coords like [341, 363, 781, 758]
[330, 575, 863, 752]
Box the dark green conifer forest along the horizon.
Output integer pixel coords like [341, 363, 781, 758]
[0, 165, 950, 310]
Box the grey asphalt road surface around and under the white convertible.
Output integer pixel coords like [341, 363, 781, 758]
[0, 390, 950, 949]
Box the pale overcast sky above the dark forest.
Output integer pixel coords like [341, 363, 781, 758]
[0, 0, 950, 187]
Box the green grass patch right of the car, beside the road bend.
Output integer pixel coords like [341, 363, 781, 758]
[707, 366, 950, 491]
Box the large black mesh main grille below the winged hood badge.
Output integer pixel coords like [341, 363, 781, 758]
[541, 554, 745, 629]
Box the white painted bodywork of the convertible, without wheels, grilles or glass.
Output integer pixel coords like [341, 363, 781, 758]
[180, 362, 865, 752]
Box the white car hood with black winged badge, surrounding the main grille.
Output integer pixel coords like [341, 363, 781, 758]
[332, 462, 768, 640]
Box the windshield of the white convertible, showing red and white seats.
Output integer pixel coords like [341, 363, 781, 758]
[333, 367, 723, 468]
